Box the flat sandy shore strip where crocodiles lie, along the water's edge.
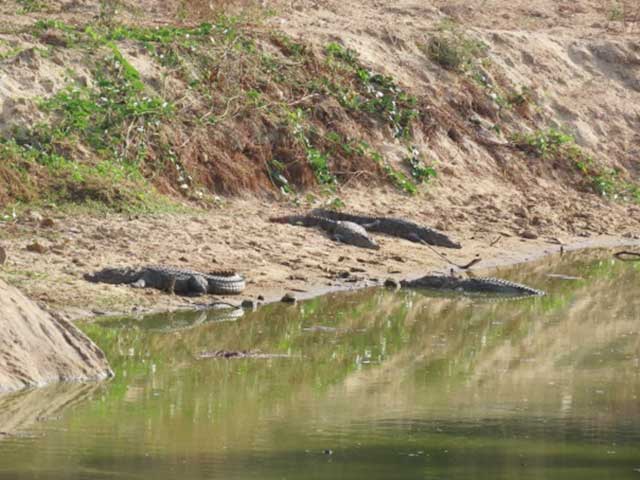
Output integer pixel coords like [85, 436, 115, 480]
[0, 190, 640, 319]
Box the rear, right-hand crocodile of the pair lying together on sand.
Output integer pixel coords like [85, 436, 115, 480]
[311, 208, 462, 248]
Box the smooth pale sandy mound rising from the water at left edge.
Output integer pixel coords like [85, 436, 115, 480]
[0, 280, 112, 394]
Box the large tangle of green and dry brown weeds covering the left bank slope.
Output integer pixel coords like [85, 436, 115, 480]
[0, 15, 435, 209]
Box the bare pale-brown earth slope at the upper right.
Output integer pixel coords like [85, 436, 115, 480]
[275, 0, 640, 188]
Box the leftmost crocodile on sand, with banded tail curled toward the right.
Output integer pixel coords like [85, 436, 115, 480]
[84, 265, 245, 295]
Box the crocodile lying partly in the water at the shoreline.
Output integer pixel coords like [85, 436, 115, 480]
[400, 275, 545, 297]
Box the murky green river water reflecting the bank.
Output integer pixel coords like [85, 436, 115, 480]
[0, 252, 640, 480]
